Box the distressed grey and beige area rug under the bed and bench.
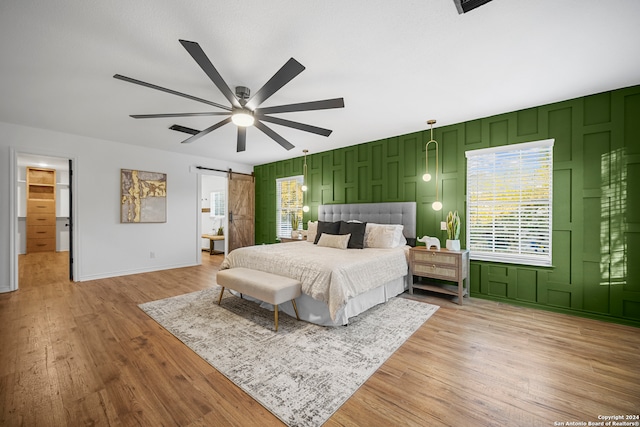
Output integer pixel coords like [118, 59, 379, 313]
[140, 286, 438, 426]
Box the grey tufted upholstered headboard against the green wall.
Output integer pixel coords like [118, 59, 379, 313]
[318, 202, 416, 240]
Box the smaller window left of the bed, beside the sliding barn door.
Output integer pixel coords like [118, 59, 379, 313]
[276, 175, 304, 237]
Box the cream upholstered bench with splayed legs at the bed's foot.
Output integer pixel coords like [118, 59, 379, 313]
[216, 267, 302, 331]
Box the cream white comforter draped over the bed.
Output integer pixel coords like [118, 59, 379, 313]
[220, 241, 408, 320]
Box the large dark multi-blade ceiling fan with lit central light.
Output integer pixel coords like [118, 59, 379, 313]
[113, 40, 344, 152]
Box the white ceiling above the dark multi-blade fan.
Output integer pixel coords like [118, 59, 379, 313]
[0, 0, 640, 165]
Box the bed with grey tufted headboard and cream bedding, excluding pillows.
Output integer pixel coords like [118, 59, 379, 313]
[220, 202, 416, 326]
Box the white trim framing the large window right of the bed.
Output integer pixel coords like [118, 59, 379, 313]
[465, 139, 555, 267]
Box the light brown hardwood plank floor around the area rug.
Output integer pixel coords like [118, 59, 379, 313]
[0, 253, 640, 426]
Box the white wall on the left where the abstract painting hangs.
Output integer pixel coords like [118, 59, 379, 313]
[0, 122, 252, 292]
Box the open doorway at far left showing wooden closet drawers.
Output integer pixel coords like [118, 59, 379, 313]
[12, 152, 74, 290]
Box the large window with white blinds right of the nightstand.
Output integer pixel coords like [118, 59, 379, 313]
[465, 139, 554, 266]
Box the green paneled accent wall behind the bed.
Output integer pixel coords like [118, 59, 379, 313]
[254, 86, 640, 326]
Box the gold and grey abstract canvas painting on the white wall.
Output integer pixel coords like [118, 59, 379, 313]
[120, 169, 167, 223]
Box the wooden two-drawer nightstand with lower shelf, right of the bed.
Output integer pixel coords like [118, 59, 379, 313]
[409, 246, 469, 305]
